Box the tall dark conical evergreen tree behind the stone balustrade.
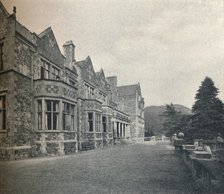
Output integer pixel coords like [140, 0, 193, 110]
[192, 77, 224, 139]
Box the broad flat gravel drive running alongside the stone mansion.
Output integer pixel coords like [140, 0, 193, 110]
[0, 142, 200, 194]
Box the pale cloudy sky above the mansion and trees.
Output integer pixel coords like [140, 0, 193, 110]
[2, 0, 224, 108]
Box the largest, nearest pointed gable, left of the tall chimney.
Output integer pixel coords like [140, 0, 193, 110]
[37, 27, 64, 66]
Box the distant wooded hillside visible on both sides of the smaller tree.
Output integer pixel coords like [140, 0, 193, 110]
[145, 104, 191, 135]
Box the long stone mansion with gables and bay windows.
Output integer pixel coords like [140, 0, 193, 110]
[0, 2, 144, 160]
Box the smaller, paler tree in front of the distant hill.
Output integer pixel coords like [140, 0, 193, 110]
[163, 103, 182, 136]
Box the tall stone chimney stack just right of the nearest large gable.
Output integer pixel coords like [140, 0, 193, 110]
[63, 40, 75, 67]
